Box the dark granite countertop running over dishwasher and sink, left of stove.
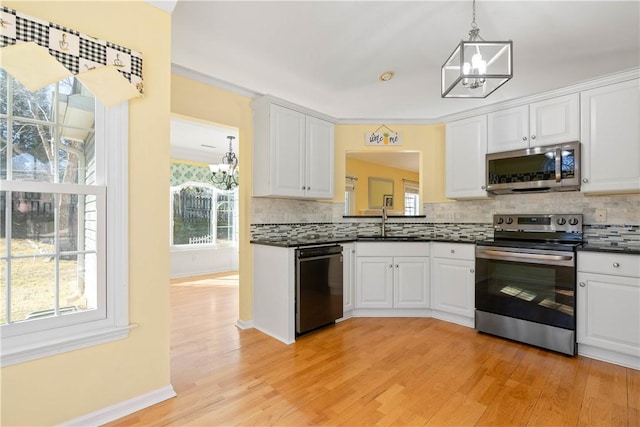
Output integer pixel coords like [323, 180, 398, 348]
[250, 236, 477, 248]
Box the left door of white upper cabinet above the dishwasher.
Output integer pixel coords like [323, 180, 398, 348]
[270, 105, 305, 196]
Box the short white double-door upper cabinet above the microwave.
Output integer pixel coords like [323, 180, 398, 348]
[487, 94, 580, 153]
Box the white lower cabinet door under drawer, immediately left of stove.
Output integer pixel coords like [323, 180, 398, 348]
[431, 258, 475, 318]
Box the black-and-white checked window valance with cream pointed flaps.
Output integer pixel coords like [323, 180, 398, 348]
[0, 7, 144, 106]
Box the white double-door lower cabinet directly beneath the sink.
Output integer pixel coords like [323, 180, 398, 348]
[355, 242, 429, 315]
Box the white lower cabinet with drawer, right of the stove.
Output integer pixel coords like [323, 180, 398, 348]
[576, 252, 640, 369]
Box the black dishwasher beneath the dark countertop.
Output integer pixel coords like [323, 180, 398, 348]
[296, 245, 344, 335]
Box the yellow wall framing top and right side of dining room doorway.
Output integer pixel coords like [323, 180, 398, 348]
[171, 74, 255, 321]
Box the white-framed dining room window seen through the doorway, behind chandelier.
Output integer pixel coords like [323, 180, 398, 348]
[171, 183, 238, 248]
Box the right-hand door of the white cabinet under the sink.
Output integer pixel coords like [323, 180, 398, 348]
[393, 257, 429, 308]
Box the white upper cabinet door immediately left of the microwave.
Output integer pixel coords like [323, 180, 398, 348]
[446, 115, 488, 199]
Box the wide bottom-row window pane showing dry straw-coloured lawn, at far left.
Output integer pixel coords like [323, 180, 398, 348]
[11, 257, 55, 322]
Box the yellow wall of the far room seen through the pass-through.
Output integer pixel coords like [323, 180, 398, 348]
[346, 158, 419, 215]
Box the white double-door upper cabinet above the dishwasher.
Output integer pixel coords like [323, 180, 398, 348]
[253, 99, 334, 199]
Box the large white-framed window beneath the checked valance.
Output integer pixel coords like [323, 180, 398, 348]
[0, 70, 128, 365]
